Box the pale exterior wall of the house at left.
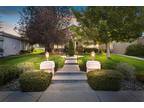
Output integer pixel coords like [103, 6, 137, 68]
[3, 37, 23, 56]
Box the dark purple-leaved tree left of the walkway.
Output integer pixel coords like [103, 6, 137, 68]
[18, 7, 72, 52]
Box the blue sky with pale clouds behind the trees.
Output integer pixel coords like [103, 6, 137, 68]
[0, 6, 84, 36]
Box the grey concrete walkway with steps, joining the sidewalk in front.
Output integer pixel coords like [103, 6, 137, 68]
[0, 57, 144, 102]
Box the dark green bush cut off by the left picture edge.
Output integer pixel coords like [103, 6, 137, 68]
[0, 65, 22, 85]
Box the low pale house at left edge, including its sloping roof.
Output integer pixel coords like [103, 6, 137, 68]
[0, 32, 29, 57]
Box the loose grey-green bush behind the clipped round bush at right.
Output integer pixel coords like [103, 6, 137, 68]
[116, 63, 135, 80]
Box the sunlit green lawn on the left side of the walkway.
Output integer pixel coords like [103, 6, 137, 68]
[0, 54, 64, 69]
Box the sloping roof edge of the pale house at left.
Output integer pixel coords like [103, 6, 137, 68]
[0, 31, 26, 41]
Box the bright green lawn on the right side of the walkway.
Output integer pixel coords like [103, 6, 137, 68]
[78, 54, 144, 72]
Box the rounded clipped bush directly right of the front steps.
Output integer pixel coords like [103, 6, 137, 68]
[87, 70, 122, 91]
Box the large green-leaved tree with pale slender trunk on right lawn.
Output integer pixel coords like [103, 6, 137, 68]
[74, 6, 144, 58]
